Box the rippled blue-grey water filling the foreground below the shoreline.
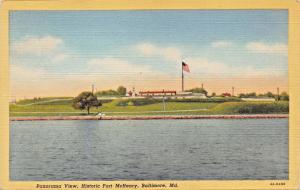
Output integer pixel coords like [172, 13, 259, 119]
[10, 119, 288, 181]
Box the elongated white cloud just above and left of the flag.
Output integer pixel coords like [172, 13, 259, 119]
[135, 43, 182, 62]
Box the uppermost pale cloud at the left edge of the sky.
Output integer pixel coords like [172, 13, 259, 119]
[12, 36, 63, 55]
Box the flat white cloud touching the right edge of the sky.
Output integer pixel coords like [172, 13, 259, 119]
[246, 42, 288, 55]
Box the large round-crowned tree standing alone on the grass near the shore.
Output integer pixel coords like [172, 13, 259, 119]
[72, 92, 102, 114]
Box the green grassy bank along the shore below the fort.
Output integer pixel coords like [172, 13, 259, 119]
[10, 98, 289, 116]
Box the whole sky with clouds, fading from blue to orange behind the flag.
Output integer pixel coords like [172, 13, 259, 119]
[10, 10, 288, 96]
